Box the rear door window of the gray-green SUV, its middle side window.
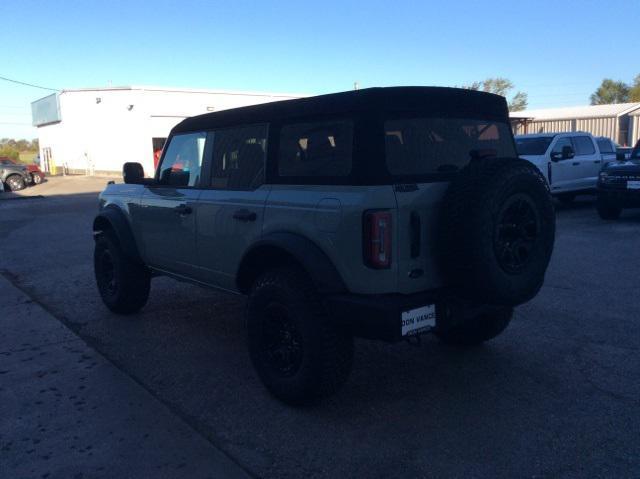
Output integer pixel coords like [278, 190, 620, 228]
[211, 125, 267, 190]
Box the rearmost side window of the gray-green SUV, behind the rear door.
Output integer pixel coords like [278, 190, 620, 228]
[278, 120, 353, 176]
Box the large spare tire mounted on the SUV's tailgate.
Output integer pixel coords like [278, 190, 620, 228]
[438, 158, 555, 306]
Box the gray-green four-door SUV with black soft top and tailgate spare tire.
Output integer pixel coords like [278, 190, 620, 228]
[93, 87, 555, 404]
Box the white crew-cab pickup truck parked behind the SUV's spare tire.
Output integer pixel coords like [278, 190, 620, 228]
[515, 131, 616, 203]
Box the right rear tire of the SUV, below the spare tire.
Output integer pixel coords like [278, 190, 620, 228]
[435, 307, 513, 346]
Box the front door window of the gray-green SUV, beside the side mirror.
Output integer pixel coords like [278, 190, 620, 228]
[158, 132, 207, 187]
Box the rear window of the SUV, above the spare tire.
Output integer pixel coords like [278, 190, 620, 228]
[384, 118, 516, 176]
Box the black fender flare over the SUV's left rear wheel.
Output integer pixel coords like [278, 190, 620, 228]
[236, 232, 347, 294]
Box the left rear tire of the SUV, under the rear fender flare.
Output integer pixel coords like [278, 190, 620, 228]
[247, 267, 353, 405]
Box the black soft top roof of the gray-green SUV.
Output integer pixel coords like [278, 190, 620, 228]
[172, 86, 509, 134]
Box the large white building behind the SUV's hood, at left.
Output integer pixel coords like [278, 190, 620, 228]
[31, 86, 302, 176]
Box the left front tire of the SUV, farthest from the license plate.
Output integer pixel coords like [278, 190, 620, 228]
[93, 233, 151, 314]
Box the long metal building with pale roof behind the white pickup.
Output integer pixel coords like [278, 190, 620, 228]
[511, 103, 640, 146]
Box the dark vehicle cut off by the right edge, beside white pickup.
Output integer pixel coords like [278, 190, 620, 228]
[596, 141, 640, 220]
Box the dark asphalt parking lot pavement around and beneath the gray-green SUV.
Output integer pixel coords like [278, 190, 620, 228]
[0, 178, 640, 478]
